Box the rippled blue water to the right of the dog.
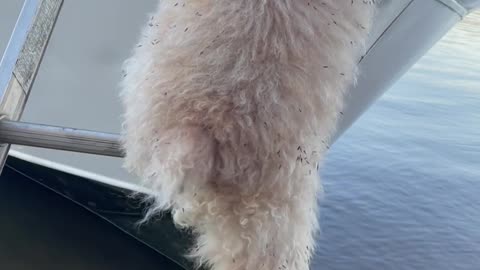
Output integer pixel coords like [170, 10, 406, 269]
[314, 13, 480, 270]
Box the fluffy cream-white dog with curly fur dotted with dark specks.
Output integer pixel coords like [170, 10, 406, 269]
[122, 0, 375, 270]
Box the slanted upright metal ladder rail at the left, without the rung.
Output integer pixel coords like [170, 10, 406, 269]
[0, 0, 63, 172]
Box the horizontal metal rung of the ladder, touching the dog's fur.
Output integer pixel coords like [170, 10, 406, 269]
[0, 120, 124, 157]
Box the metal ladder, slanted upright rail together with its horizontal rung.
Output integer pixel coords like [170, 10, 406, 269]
[0, 0, 123, 171]
